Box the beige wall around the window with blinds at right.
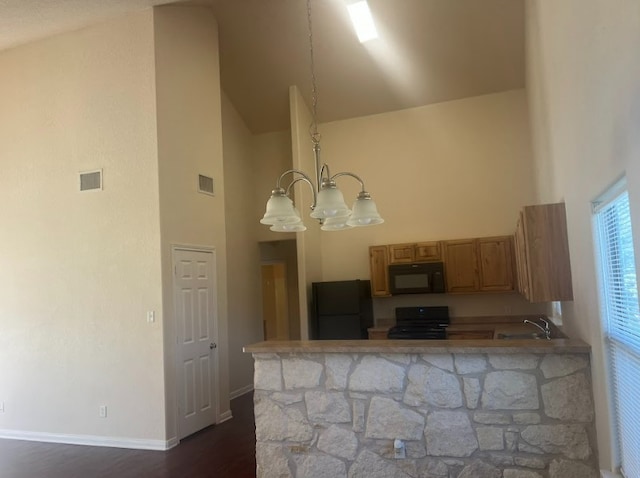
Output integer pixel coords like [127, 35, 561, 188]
[527, 0, 640, 469]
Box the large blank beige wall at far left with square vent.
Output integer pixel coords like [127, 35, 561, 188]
[0, 10, 165, 446]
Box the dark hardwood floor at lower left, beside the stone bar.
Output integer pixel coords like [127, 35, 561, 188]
[0, 393, 256, 478]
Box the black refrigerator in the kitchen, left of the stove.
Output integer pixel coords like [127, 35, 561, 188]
[310, 280, 373, 340]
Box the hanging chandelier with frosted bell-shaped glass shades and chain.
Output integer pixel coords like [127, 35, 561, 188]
[260, 0, 384, 232]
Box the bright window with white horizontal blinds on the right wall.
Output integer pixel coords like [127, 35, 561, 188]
[593, 181, 640, 478]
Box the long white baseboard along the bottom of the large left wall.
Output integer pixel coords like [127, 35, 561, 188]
[0, 429, 172, 450]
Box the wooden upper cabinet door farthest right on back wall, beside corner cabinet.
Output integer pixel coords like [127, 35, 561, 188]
[477, 236, 514, 292]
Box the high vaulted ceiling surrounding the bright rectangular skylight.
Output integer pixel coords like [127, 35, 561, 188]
[0, 0, 525, 133]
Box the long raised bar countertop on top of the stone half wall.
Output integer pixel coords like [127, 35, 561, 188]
[244, 339, 591, 354]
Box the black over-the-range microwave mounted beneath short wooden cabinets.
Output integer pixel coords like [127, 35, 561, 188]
[388, 262, 445, 295]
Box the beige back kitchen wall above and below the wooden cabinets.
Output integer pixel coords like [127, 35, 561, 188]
[320, 90, 544, 318]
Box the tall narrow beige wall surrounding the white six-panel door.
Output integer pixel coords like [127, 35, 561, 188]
[154, 6, 230, 438]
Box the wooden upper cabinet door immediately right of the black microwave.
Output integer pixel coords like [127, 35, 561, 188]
[443, 239, 480, 293]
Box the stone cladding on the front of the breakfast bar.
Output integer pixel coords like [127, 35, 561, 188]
[254, 353, 598, 478]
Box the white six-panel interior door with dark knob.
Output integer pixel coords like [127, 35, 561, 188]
[173, 248, 217, 439]
